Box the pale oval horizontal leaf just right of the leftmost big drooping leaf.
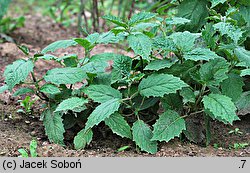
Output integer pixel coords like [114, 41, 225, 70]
[44, 67, 87, 85]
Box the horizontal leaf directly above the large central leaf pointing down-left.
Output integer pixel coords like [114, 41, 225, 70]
[84, 85, 122, 103]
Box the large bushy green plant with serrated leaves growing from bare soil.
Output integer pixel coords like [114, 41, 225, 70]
[0, 0, 250, 154]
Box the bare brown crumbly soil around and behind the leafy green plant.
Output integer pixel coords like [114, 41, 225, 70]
[0, 12, 250, 157]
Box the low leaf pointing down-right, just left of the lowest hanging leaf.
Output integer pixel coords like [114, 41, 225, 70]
[104, 113, 132, 139]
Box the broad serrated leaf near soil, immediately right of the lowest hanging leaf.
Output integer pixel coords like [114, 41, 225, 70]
[151, 110, 186, 142]
